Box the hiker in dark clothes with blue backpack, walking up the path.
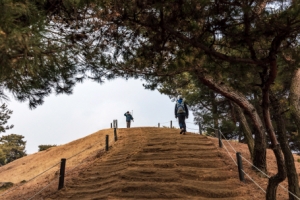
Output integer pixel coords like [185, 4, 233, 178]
[175, 96, 189, 135]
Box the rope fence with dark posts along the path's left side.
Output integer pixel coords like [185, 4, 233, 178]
[0, 120, 117, 200]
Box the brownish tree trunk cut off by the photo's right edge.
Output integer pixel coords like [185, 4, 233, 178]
[289, 69, 300, 133]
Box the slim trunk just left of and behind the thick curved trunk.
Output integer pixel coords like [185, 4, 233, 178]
[234, 104, 254, 160]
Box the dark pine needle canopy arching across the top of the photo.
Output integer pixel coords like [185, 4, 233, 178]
[0, 0, 300, 155]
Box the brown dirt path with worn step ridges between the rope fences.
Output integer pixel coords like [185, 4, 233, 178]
[46, 128, 251, 200]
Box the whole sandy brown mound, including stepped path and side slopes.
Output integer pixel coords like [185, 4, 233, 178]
[0, 127, 300, 200]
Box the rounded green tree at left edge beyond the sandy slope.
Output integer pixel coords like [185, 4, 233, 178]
[0, 134, 27, 165]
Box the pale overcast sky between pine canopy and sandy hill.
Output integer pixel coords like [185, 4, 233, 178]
[2, 79, 198, 154]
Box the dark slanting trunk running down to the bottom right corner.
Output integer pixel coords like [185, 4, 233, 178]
[270, 93, 300, 200]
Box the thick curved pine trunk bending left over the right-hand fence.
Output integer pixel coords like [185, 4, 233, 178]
[195, 70, 267, 172]
